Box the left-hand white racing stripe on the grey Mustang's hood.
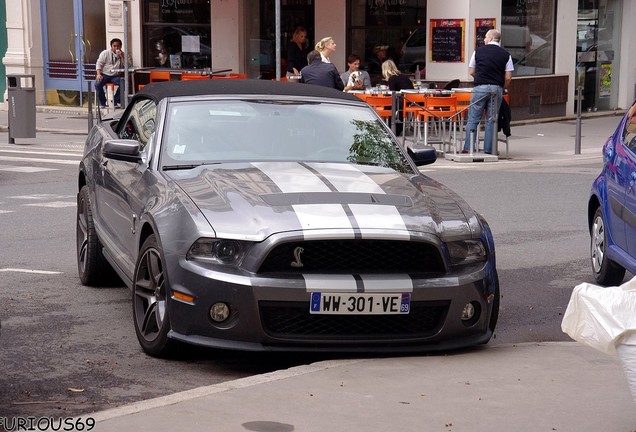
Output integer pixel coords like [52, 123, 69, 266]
[252, 162, 354, 237]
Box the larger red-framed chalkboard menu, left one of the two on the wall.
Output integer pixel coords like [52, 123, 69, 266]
[430, 20, 464, 63]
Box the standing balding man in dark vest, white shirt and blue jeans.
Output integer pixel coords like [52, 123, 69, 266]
[462, 29, 514, 154]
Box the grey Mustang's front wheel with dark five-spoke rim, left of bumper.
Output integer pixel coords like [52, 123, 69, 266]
[132, 234, 175, 357]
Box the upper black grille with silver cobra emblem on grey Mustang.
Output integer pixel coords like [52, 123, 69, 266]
[259, 240, 444, 274]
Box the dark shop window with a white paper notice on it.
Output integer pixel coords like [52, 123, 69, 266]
[142, 0, 212, 69]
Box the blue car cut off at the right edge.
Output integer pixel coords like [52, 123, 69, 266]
[588, 102, 636, 285]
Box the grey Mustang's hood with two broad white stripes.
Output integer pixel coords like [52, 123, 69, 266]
[168, 162, 474, 241]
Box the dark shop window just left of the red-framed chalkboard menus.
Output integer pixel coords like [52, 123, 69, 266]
[346, 0, 426, 84]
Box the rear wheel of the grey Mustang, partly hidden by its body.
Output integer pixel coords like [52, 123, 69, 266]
[75, 186, 115, 286]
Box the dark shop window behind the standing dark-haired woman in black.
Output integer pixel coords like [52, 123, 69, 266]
[245, 0, 316, 79]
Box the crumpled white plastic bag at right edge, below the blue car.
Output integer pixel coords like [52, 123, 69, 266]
[561, 277, 636, 354]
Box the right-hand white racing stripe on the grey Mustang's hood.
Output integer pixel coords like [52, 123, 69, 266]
[307, 163, 410, 240]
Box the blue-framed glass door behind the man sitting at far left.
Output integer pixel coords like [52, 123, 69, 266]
[42, 0, 107, 106]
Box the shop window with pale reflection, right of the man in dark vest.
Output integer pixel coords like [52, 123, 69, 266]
[501, 0, 556, 76]
